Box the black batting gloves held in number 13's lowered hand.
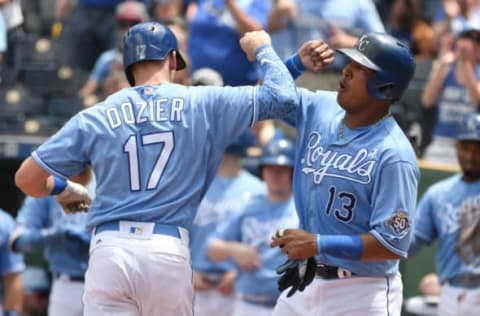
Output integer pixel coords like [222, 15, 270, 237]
[277, 257, 317, 297]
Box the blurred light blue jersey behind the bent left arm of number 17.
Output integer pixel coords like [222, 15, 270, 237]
[17, 196, 89, 276]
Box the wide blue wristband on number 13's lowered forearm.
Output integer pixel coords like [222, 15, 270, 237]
[317, 235, 363, 261]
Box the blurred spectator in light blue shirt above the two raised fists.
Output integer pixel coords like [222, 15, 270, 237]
[269, 0, 385, 65]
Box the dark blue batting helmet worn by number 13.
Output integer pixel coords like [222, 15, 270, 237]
[337, 33, 415, 101]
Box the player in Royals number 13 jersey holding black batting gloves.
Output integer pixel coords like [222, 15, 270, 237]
[271, 33, 419, 316]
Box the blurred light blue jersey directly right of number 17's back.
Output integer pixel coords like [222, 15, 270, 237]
[190, 171, 266, 273]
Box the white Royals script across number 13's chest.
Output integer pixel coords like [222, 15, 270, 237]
[301, 131, 377, 184]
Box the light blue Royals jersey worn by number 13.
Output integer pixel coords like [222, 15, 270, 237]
[290, 89, 420, 276]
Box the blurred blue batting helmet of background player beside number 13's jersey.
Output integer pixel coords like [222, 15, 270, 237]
[260, 139, 295, 167]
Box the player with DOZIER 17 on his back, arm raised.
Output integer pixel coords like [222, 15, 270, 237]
[15, 22, 308, 316]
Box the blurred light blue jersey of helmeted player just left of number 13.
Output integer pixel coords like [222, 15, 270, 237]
[211, 196, 298, 301]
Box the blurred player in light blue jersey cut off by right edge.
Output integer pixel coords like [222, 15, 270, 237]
[409, 113, 480, 315]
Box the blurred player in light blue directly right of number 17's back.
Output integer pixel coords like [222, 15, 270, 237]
[190, 133, 266, 316]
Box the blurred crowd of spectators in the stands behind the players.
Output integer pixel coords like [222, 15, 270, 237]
[0, 0, 480, 315]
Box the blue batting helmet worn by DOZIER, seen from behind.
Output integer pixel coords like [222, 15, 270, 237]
[123, 22, 186, 86]
